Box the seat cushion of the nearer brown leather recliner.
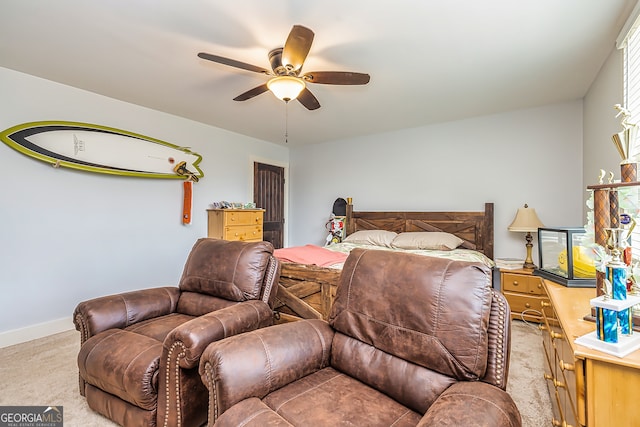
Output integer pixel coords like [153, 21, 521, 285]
[263, 368, 421, 427]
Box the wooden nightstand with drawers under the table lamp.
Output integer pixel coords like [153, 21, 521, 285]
[500, 269, 553, 323]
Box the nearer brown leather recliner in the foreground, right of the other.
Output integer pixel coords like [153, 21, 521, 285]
[200, 249, 521, 427]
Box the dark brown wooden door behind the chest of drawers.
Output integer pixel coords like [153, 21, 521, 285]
[253, 162, 284, 249]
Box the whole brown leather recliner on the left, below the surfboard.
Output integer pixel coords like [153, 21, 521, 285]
[74, 239, 280, 426]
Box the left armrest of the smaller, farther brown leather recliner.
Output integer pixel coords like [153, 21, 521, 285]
[73, 287, 180, 343]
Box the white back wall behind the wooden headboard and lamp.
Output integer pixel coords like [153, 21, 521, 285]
[289, 100, 584, 259]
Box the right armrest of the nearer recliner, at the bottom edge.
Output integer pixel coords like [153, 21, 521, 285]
[418, 381, 522, 427]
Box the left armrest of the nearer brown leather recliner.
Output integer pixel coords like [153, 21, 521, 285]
[200, 319, 335, 425]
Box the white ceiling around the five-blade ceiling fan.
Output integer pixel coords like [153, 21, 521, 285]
[0, 0, 636, 146]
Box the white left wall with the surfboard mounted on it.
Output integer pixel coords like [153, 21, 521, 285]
[0, 68, 289, 346]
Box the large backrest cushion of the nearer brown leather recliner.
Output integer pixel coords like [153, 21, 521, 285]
[329, 249, 491, 380]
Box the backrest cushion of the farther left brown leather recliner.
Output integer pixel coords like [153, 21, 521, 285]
[179, 238, 273, 301]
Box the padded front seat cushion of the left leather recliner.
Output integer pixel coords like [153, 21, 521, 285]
[78, 329, 162, 410]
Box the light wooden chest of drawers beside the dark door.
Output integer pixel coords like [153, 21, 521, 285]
[207, 209, 264, 242]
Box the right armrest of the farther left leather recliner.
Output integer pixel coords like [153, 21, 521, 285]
[163, 300, 273, 369]
